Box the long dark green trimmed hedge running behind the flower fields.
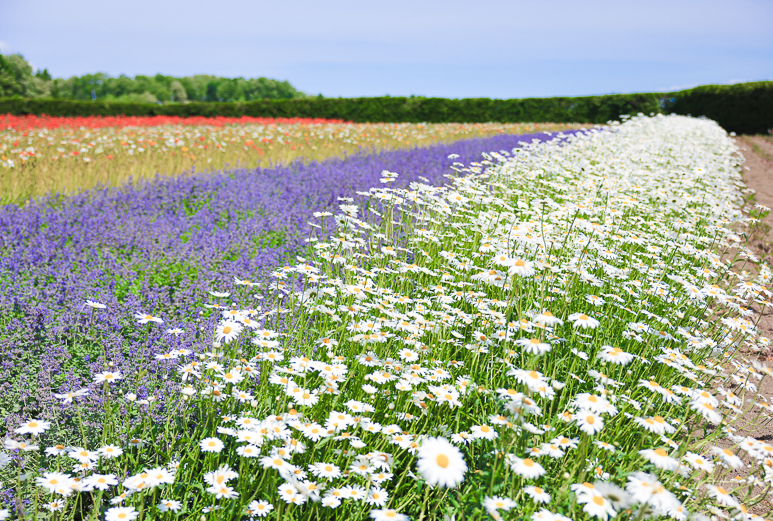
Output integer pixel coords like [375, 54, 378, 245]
[0, 81, 773, 133]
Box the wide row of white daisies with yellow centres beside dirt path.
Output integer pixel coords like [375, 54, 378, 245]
[0, 116, 773, 521]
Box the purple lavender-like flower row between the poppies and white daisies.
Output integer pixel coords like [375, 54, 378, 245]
[0, 128, 584, 435]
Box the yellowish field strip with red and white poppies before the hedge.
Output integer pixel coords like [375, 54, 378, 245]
[0, 115, 587, 203]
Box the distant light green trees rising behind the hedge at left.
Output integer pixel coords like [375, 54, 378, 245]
[0, 54, 309, 103]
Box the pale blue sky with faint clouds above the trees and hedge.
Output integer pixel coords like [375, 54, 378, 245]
[0, 0, 773, 98]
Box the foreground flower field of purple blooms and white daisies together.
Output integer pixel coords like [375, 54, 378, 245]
[0, 116, 773, 521]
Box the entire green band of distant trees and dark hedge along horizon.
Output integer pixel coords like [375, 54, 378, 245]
[0, 51, 773, 134]
